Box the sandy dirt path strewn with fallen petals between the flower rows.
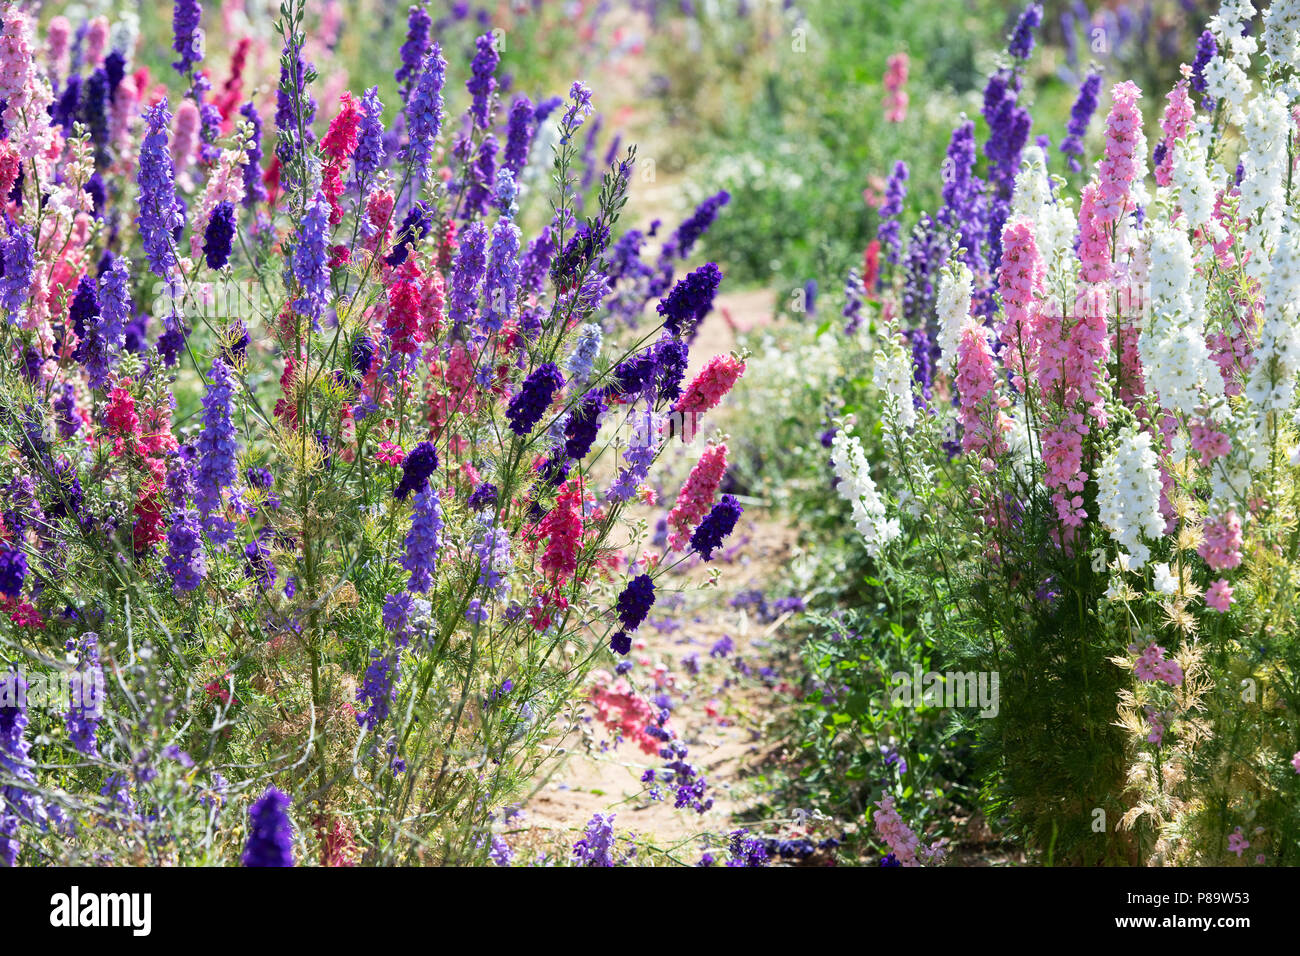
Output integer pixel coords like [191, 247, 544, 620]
[506, 291, 821, 864]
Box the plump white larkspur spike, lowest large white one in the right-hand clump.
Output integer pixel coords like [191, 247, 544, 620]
[1097, 425, 1165, 568]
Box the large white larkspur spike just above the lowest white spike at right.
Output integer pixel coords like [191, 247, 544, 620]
[1138, 216, 1223, 418]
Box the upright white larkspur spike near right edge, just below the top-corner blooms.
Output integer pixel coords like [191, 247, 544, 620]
[1238, 90, 1291, 280]
